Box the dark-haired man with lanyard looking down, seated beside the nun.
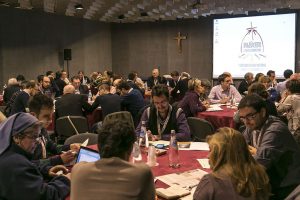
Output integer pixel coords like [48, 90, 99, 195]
[28, 94, 80, 165]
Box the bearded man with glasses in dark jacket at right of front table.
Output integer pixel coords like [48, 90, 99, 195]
[238, 94, 300, 199]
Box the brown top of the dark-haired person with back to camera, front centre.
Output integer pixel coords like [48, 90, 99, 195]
[71, 157, 155, 200]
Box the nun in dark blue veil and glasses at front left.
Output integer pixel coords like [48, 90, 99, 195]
[0, 113, 70, 199]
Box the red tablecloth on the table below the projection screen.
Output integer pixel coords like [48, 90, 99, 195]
[197, 106, 237, 129]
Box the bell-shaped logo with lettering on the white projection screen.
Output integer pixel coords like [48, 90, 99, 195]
[240, 22, 266, 60]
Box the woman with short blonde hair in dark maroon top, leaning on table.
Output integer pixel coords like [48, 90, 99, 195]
[178, 79, 209, 118]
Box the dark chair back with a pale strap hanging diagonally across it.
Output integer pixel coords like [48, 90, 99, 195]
[55, 116, 89, 139]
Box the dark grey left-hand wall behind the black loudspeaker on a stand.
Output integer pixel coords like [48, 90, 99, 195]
[0, 8, 111, 83]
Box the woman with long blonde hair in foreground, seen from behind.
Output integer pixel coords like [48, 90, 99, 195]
[194, 128, 270, 200]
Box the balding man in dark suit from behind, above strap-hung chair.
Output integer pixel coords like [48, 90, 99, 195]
[55, 85, 92, 119]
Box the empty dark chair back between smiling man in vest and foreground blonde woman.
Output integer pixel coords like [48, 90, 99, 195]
[187, 117, 214, 142]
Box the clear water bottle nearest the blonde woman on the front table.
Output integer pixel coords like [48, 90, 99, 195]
[169, 130, 180, 168]
